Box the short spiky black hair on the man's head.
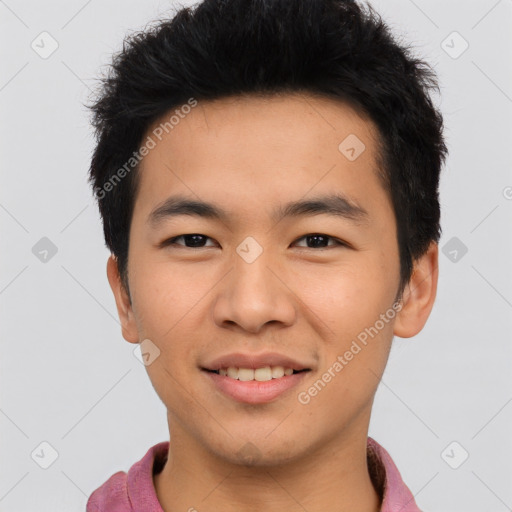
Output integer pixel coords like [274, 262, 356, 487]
[88, 0, 447, 298]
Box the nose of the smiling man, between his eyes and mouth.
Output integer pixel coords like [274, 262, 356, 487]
[213, 245, 297, 334]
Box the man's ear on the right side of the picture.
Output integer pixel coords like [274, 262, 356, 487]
[393, 242, 439, 338]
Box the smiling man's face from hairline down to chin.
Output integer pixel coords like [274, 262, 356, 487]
[109, 95, 432, 465]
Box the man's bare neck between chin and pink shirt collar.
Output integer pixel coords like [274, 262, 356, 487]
[154, 423, 381, 512]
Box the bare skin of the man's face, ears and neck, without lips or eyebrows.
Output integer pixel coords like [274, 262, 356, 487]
[107, 94, 438, 512]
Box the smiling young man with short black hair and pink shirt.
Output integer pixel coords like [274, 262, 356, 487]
[87, 0, 447, 512]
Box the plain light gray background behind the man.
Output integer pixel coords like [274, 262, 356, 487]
[0, 0, 512, 512]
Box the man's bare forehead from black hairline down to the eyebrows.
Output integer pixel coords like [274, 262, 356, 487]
[136, 93, 390, 228]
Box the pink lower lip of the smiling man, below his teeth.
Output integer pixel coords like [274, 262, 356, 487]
[202, 370, 309, 404]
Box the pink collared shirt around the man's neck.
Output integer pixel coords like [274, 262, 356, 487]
[86, 437, 421, 512]
